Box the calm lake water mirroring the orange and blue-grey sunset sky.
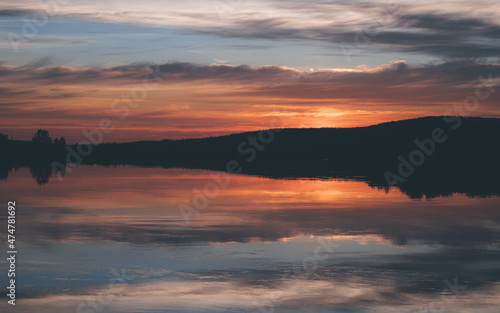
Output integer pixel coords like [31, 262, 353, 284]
[0, 166, 500, 313]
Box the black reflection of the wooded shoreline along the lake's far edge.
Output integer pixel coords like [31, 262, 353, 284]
[0, 159, 500, 199]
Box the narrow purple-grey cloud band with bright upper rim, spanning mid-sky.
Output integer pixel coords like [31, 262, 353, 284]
[0, 61, 500, 85]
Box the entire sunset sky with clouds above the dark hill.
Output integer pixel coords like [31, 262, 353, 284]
[0, 0, 500, 142]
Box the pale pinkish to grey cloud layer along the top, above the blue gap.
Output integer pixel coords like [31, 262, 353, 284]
[0, 0, 500, 59]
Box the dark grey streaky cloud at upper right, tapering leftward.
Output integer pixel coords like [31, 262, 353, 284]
[193, 10, 500, 59]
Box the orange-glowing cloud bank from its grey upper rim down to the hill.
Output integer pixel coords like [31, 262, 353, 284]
[0, 61, 500, 141]
